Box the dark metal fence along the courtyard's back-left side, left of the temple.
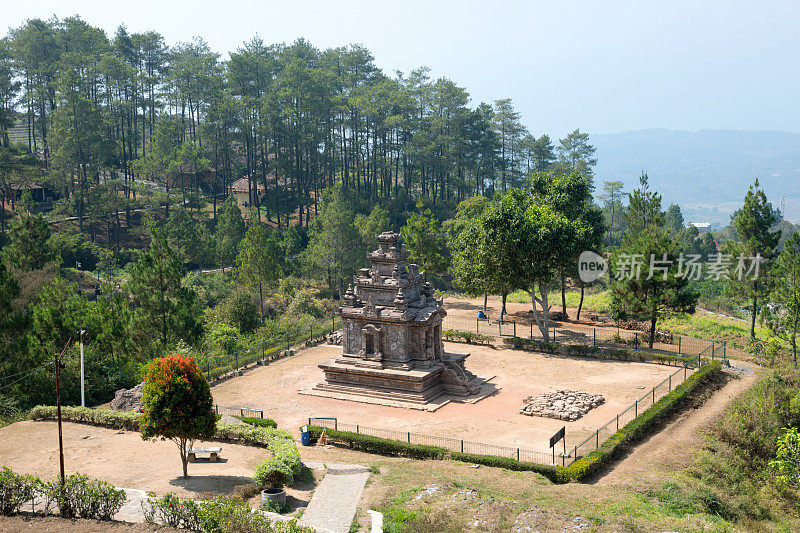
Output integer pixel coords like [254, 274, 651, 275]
[197, 316, 342, 383]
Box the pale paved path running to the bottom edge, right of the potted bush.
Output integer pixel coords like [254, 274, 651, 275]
[302, 463, 369, 533]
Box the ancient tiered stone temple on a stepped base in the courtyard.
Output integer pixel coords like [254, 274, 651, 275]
[304, 232, 487, 409]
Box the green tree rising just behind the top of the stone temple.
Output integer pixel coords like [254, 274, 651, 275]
[400, 202, 448, 279]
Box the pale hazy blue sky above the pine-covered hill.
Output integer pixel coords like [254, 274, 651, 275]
[0, 0, 800, 136]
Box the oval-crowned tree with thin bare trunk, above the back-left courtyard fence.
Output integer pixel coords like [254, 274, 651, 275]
[236, 223, 283, 322]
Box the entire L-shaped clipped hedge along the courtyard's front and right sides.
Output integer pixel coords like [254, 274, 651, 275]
[309, 362, 721, 483]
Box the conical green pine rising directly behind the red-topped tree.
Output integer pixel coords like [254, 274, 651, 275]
[129, 232, 200, 348]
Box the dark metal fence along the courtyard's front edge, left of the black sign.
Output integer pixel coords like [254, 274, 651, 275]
[308, 417, 567, 465]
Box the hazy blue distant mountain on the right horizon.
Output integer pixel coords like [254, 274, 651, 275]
[590, 129, 800, 226]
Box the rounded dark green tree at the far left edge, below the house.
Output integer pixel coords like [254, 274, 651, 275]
[3, 213, 55, 270]
